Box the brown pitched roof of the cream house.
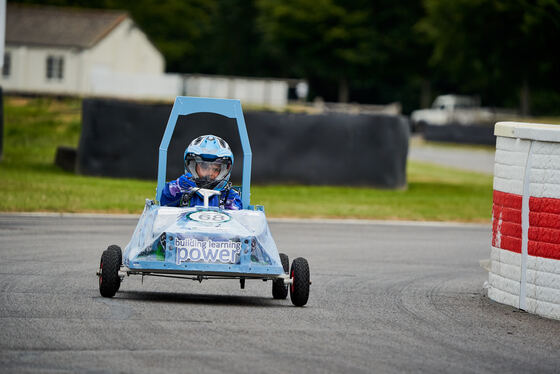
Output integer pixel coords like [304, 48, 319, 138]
[6, 4, 128, 48]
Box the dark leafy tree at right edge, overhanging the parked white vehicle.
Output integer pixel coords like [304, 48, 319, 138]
[419, 0, 560, 114]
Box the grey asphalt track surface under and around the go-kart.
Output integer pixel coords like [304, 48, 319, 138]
[0, 215, 560, 373]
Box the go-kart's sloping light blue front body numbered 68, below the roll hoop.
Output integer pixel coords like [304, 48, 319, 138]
[123, 201, 284, 278]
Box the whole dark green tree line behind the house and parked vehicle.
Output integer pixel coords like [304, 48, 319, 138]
[9, 0, 560, 115]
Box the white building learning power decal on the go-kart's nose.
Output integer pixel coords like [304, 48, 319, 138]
[175, 238, 241, 265]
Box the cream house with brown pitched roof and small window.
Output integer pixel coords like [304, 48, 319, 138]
[0, 4, 165, 95]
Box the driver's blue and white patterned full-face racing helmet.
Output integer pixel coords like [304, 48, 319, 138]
[184, 135, 233, 190]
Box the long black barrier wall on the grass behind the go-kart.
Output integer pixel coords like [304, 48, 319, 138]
[77, 99, 409, 188]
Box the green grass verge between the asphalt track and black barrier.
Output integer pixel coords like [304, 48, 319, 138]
[0, 97, 492, 222]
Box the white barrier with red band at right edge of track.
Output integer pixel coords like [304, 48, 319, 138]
[488, 122, 560, 319]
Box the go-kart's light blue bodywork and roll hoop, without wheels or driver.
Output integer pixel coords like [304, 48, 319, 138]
[121, 96, 286, 279]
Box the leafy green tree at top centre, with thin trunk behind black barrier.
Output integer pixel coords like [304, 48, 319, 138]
[257, 0, 376, 101]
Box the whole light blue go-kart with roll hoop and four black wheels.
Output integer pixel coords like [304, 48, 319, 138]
[97, 96, 311, 306]
